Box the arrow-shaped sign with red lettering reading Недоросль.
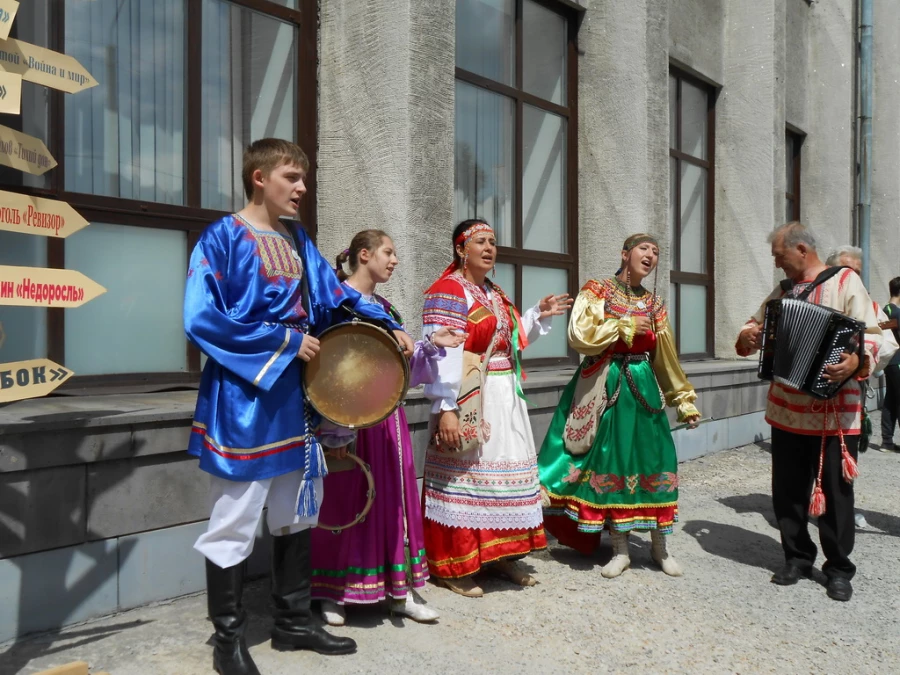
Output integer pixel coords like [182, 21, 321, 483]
[0, 265, 106, 307]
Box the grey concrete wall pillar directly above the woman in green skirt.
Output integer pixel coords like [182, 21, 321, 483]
[578, 0, 669, 291]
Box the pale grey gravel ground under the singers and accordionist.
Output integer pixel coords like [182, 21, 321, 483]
[0, 419, 900, 675]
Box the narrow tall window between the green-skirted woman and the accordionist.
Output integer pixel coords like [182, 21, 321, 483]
[669, 70, 715, 358]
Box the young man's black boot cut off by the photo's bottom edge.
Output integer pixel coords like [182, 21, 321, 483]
[206, 560, 260, 675]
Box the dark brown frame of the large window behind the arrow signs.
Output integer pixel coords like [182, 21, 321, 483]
[0, 0, 318, 393]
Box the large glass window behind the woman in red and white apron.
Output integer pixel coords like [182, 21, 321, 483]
[454, 0, 578, 364]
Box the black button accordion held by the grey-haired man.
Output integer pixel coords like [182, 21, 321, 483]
[759, 298, 866, 399]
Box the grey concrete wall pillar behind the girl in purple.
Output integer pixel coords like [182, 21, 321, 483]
[317, 0, 455, 334]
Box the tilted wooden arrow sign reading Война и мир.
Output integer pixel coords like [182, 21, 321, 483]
[0, 38, 98, 94]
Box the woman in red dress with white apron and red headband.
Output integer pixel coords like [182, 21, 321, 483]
[422, 220, 572, 597]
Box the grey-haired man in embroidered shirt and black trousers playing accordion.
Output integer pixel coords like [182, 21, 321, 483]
[735, 222, 882, 601]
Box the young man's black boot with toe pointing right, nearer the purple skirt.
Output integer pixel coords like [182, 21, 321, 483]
[272, 530, 356, 654]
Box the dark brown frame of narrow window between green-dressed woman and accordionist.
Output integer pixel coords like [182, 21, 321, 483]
[669, 65, 718, 361]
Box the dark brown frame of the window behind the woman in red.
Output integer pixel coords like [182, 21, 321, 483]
[454, 0, 579, 367]
